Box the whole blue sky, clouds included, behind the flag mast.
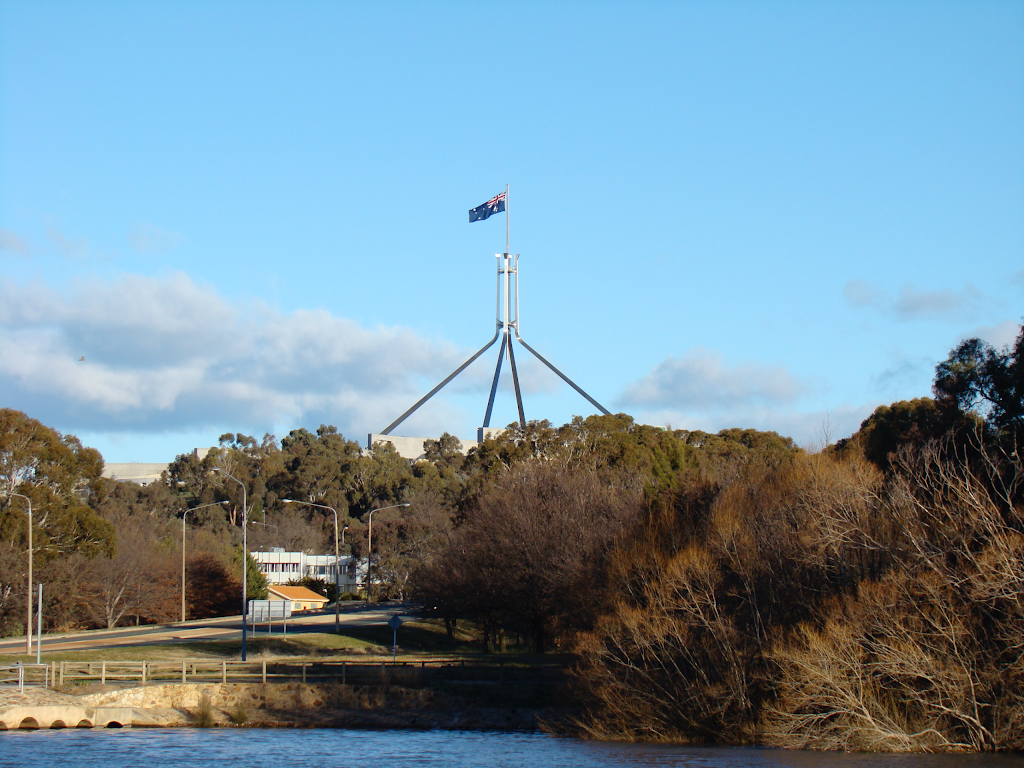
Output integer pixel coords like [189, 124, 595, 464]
[0, 0, 1024, 462]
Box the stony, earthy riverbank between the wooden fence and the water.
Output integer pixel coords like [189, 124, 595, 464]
[0, 683, 556, 731]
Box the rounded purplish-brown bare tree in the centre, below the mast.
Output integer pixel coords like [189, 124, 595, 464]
[414, 462, 641, 652]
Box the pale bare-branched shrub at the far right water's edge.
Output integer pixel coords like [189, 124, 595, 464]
[761, 444, 1024, 751]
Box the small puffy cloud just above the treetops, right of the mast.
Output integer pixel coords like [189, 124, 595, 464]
[620, 348, 807, 413]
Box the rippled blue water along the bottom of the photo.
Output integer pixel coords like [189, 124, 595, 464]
[0, 728, 1024, 768]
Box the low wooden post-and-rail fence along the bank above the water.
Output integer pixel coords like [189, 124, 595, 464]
[51, 659, 562, 687]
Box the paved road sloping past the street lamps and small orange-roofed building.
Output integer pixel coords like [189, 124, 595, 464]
[0, 603, 410, 655]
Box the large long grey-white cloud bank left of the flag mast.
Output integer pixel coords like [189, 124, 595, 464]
[0, 274, 489, 442]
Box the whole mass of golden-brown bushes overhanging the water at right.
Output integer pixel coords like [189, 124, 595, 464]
[574, 438, 1024, 751]
